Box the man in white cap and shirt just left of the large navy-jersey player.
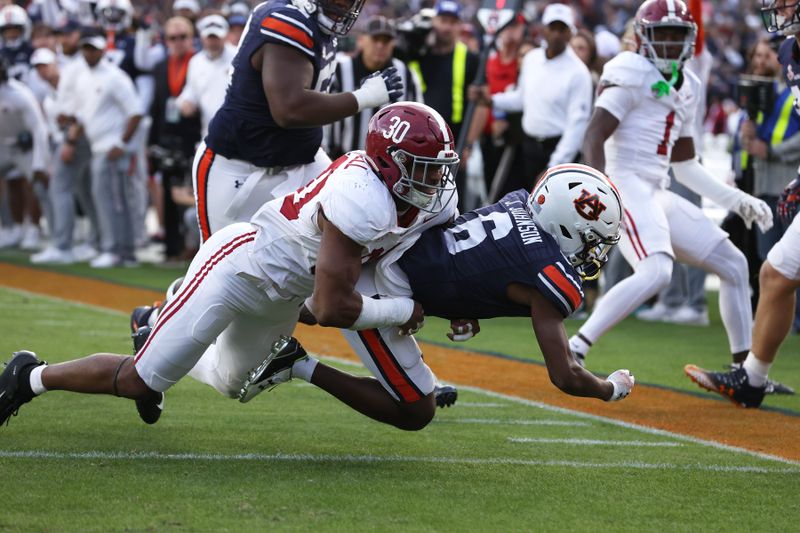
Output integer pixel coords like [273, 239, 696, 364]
[177, 15, 236, 137]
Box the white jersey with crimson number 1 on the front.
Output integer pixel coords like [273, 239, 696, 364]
[595, 52, 701, 187]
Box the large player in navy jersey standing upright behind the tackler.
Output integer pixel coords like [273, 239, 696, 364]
[192, 0, 403, 241]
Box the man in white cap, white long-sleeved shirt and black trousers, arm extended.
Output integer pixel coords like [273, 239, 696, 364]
[484, 4, 592, 186]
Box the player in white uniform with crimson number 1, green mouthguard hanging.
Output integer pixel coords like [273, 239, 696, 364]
[570, 0, 772, 372]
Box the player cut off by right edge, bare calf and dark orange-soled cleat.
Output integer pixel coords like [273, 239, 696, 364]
[684, 0, 800, 407]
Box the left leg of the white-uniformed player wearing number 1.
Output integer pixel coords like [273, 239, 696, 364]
[569, 177, 673, 361]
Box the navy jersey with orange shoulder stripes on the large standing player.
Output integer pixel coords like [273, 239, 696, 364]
[206, 0, 336, 167]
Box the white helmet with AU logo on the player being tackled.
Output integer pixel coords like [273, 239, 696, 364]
[528, 164, 622, 279]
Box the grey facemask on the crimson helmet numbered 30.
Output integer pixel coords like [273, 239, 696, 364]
[390, 148, 460, 213]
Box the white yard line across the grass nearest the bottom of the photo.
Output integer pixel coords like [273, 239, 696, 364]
[0, 450, 800, 474]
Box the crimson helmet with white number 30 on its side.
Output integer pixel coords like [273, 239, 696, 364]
[366, 102, 460, 213]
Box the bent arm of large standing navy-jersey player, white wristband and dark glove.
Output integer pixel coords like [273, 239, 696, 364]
[260, 43, 403, 128]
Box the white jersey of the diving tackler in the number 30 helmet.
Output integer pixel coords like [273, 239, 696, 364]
[250, 151, 457, 297]
